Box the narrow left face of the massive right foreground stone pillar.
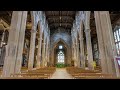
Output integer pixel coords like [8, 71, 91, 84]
[94, 11, 108, 73]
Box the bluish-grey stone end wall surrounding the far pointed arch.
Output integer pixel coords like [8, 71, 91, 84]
[50, 29, 72, 64]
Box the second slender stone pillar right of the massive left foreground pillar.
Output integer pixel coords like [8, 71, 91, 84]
[36, 32, 42, 68]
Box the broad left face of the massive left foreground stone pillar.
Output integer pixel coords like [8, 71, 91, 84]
[2, 11, 23, 77]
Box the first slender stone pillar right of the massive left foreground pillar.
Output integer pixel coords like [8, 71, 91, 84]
[28, 27, 36, 70]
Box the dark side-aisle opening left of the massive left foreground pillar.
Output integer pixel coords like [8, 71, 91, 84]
[0, 11, 13, 70]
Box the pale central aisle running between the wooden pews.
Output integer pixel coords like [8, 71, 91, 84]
[50, 68, 72, 79]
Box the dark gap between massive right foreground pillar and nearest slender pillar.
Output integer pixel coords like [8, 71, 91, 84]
[90, 12, 101, 70]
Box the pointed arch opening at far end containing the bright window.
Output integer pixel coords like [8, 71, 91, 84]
[52, 39, 70, 67]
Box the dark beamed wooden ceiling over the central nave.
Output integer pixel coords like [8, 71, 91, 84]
[45, 11, 76, 33]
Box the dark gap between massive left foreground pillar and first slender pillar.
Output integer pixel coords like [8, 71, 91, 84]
[21, 11, 31, 70]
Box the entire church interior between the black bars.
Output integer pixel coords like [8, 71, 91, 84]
[0, 11, 120, 79]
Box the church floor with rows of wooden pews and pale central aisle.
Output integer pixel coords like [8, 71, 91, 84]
[0, 67, 120, 79]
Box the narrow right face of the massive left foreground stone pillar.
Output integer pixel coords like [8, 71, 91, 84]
[15, 11, 27, 73]
